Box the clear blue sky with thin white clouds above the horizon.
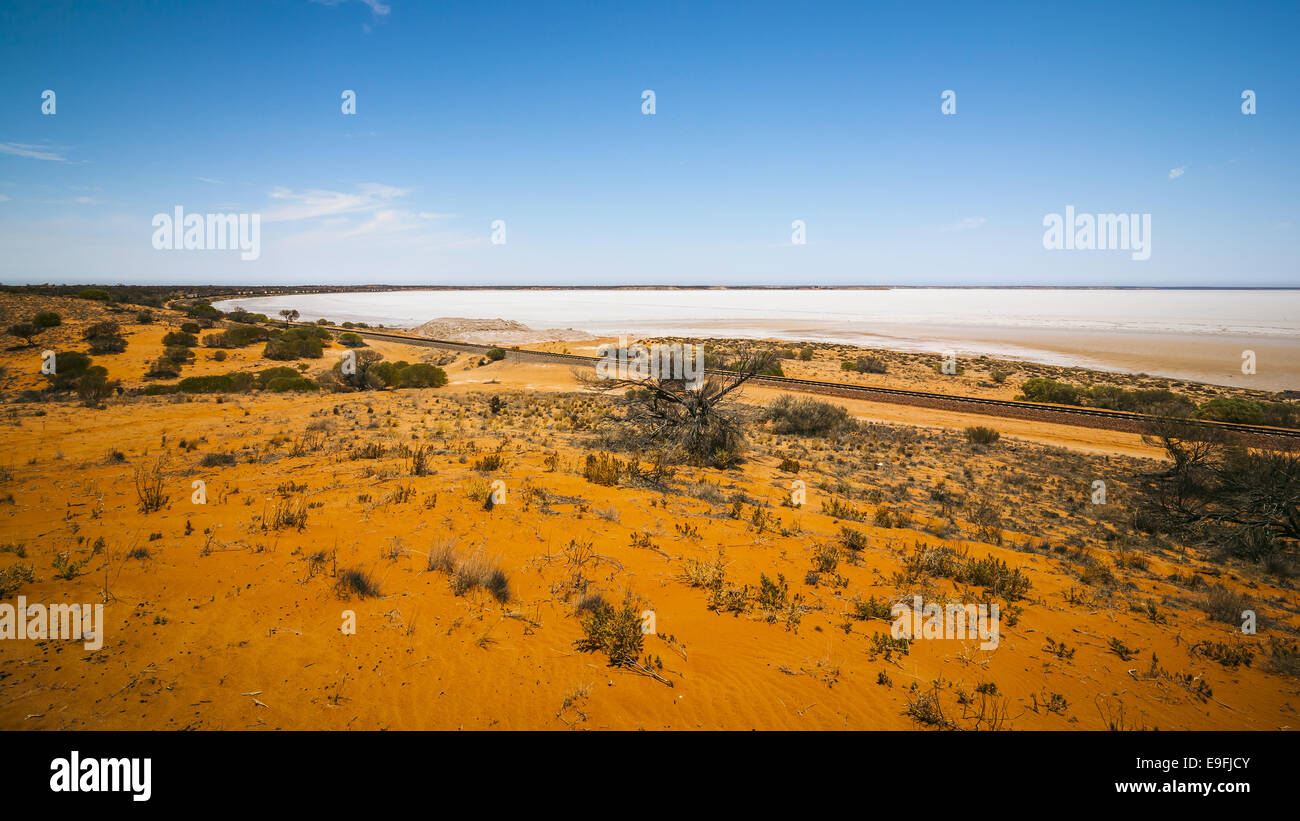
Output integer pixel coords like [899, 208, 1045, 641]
[0, 0, 1300, 286]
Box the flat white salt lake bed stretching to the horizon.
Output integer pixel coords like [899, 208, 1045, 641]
[215, 287, 1300, 391]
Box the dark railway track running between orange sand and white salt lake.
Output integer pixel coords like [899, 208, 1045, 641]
[314, 322, 1300, 451]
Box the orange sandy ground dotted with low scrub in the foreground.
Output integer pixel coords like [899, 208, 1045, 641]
[0, 294, 1300, 730]
